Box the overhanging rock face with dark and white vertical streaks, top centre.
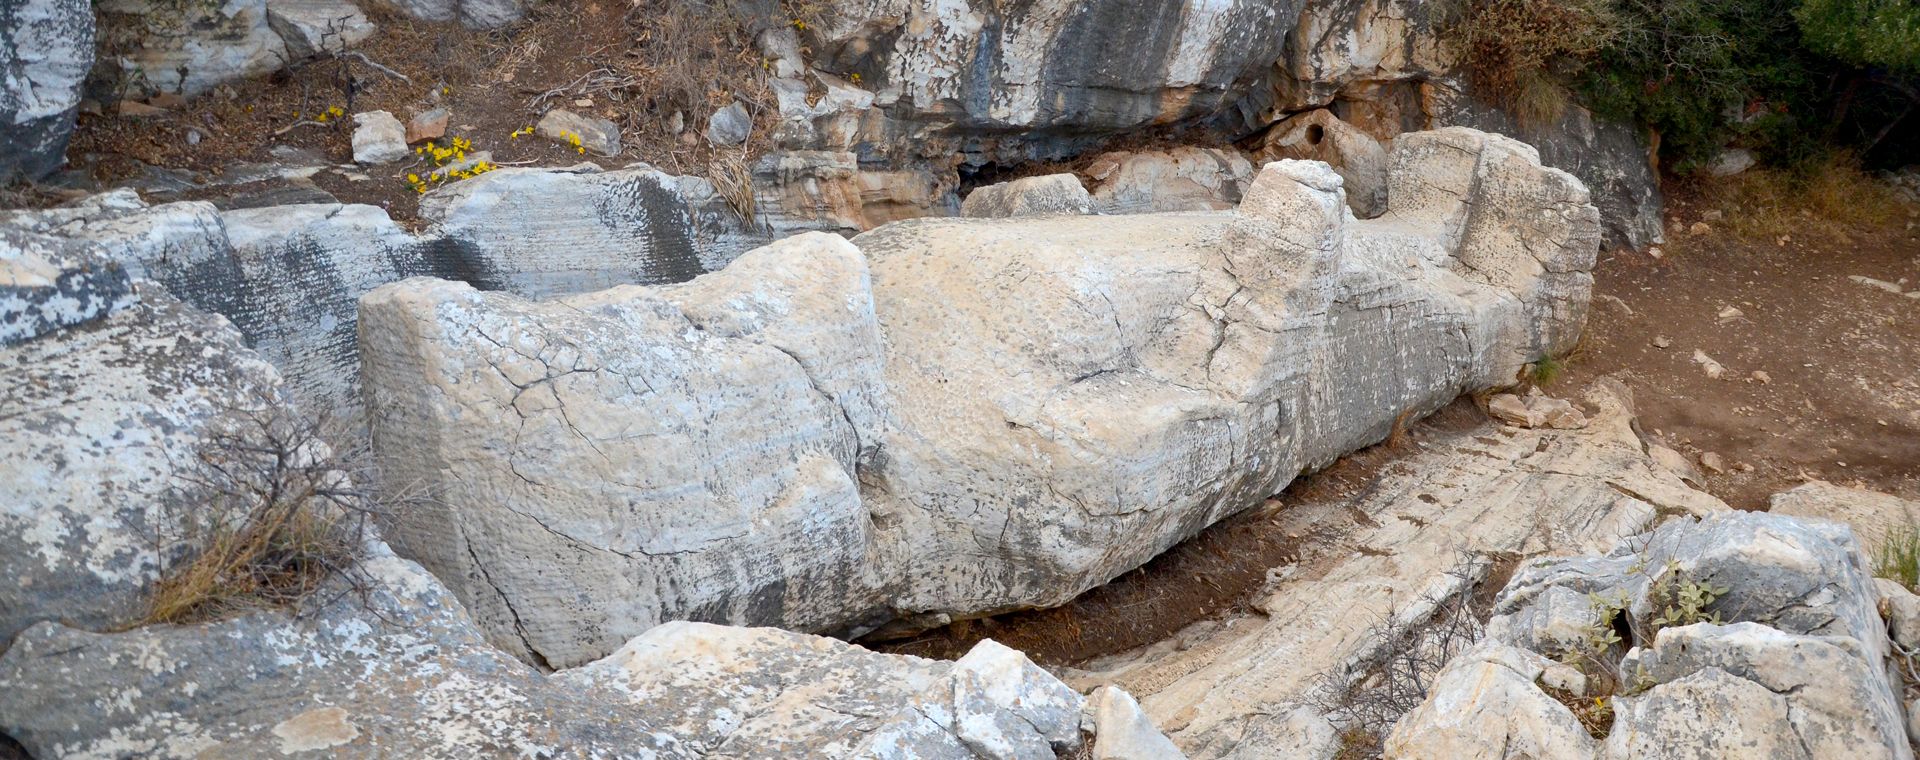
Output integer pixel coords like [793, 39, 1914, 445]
[810, 0, 1300, 161]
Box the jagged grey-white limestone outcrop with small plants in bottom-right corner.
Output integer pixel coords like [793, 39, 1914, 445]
[1386, 512, 1914, 758]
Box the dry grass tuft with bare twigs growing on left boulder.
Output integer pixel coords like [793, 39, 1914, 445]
[140, 405, 389, 624]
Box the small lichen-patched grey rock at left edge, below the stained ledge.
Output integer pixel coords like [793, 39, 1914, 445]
[0, 226, 134, 345]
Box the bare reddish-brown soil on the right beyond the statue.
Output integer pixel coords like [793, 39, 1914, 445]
[1549, 188, 1920, 511]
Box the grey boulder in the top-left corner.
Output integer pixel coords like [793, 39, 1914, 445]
[0, 0, 94, 184]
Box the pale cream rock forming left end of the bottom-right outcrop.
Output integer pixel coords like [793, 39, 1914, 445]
[1382, 643, 1596, 760]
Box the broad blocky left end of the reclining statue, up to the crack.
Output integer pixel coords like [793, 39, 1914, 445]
[361, 234, 883, 666]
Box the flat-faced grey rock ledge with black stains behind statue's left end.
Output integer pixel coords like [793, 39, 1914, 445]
[0, 169, 764, 427]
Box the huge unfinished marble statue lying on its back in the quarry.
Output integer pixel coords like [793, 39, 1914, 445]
[359, 129, 1599, 666]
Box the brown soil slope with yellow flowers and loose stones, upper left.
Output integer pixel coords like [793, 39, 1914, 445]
[63, 0, 772, 221]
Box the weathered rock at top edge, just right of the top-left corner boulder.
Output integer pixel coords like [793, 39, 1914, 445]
[96, 0, 288, 96]
